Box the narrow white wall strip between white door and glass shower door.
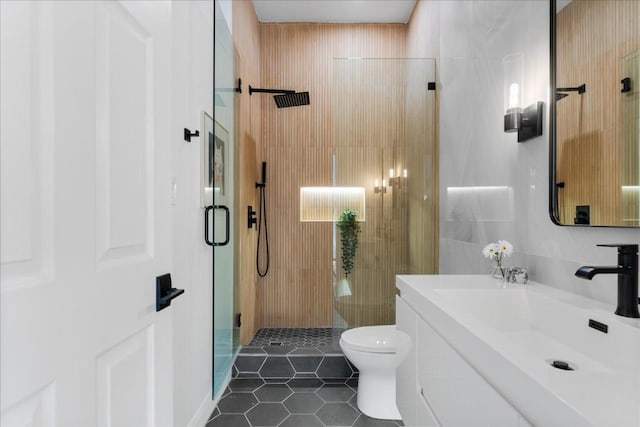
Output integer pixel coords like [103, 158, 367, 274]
[171, 0, 215, 426]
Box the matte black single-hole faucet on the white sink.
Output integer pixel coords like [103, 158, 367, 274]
[576, 244, 640, 317]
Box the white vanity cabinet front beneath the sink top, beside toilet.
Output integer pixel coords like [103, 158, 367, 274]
[396, 297, 529, 427]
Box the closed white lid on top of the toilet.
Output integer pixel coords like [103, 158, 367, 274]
[340, 325, 409, 353]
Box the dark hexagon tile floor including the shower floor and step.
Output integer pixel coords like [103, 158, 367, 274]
[207, 328, 404, 427]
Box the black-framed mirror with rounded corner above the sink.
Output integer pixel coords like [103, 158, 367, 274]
[549, 0, 640, 227]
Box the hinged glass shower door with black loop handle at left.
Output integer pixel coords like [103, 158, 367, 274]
[214, 1, 239, 396]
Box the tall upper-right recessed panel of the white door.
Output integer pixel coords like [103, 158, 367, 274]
[96, 3, 154, 268]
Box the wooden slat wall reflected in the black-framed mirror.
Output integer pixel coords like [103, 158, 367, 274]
[557, 0, 640, 225]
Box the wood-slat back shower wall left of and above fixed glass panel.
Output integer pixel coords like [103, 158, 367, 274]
[258, 24, 406, 327]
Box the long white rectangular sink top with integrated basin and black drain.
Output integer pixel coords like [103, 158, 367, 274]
[397, 275, 640, 427]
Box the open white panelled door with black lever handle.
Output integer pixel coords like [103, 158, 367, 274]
[0, 0, 175, 427]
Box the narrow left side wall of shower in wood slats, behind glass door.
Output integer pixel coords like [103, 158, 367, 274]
[233, 1, 261, 345]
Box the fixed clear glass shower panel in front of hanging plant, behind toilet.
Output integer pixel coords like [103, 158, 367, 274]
[332, 59, 438, 327]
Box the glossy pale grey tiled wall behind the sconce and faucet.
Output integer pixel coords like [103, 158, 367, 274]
[413, 1, 640, 304]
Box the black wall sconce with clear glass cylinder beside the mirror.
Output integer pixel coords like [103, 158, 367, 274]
[502, 53, 543, 142]
